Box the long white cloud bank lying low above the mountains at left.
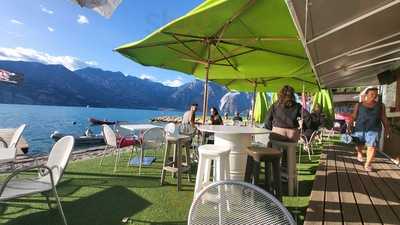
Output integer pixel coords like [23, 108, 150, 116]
[0, 47, 98, 70]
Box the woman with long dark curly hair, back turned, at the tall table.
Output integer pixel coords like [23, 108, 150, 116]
[265, 85, 310, 142]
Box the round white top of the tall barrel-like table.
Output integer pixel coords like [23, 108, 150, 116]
[197, 125, 271, 134]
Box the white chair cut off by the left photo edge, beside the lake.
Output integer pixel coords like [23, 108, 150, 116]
[0, 124, 26, 168]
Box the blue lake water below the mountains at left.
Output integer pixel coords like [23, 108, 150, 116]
[0, 104, 183, 154]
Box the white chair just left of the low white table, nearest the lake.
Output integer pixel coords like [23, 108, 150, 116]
[100, 124, 121, 173]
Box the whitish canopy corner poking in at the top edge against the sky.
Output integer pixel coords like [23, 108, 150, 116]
[72, 0, 122, 18]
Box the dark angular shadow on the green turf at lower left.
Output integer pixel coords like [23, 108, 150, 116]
[5, 186, 151, 225]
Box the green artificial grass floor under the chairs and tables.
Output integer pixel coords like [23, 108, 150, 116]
[0, 141, 326, 225]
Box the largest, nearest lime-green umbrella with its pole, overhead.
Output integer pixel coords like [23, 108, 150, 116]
[115, 0, 313, 120]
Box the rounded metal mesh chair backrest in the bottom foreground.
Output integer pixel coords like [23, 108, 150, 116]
[188, 181, 296, 225]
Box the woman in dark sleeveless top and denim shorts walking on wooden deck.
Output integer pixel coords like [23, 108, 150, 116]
[350, 87, 390, 172]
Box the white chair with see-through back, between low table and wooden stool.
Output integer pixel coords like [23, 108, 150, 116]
[139, 127, 165, 175]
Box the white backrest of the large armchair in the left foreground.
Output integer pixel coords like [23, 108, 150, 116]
[46, 136, 75, 185]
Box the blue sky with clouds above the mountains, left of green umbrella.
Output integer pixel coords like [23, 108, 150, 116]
[0, 0, 202, 86]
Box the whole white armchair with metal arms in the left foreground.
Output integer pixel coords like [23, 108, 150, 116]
[0, 136, 74, 225]
